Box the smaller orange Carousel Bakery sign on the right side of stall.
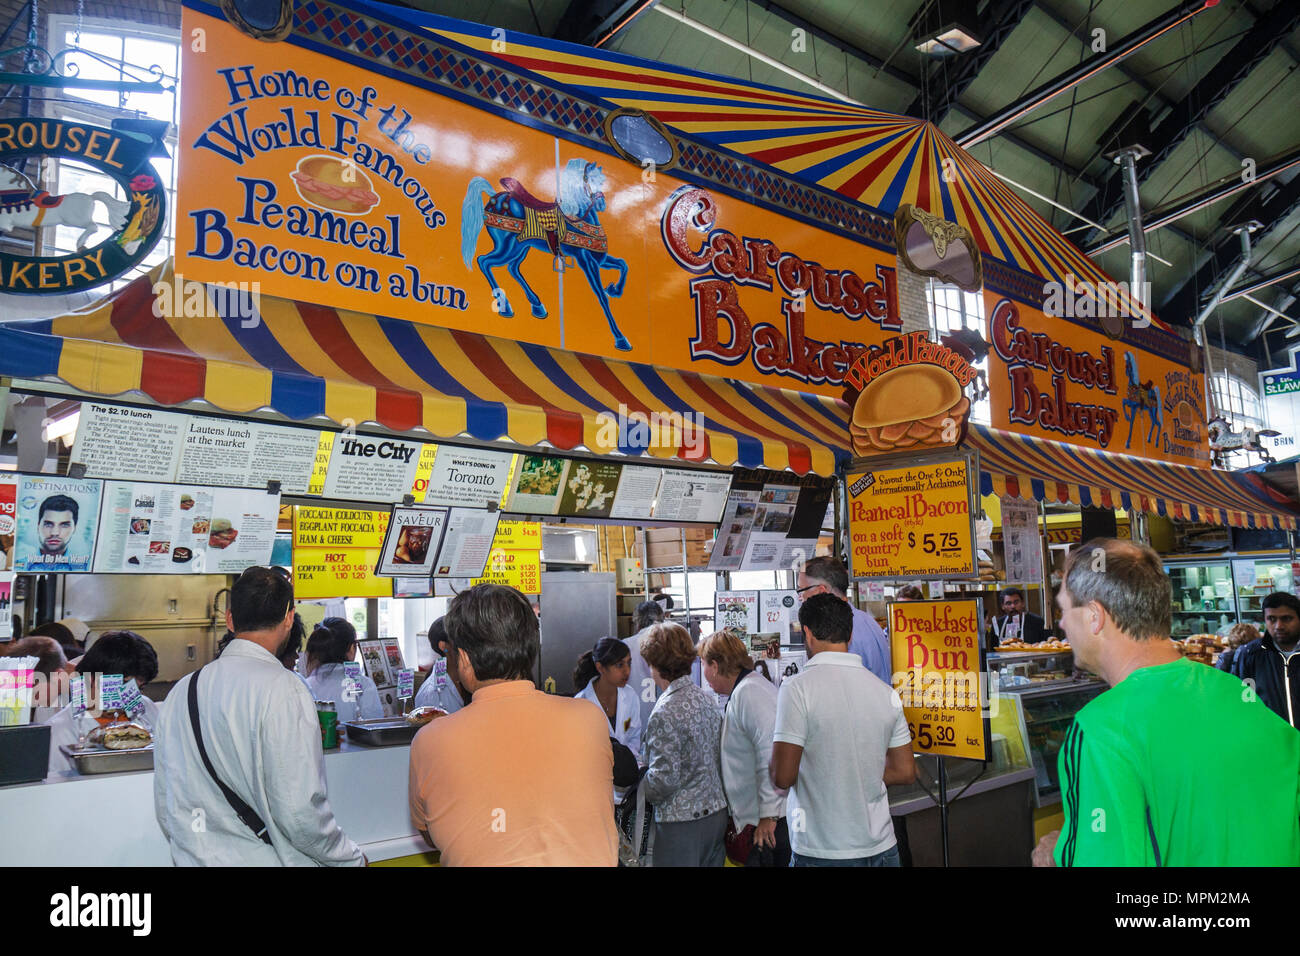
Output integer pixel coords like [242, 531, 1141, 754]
[984, 290, 1209, 467]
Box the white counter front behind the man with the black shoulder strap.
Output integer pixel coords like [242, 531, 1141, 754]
[0, 743, 429, 866]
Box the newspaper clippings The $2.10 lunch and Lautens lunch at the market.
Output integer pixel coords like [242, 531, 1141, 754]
[72, 402, 320, 494]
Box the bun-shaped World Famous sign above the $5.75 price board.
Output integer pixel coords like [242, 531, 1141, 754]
[844, 332, 983, 458]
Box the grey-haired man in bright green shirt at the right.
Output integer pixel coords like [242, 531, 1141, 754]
[1035, 538, 1300, 866]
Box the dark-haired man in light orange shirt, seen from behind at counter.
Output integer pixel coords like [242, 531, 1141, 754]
[410, 584, 619, 866]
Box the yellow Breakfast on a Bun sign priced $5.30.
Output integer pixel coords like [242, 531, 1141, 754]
[889, 600, 988, 760]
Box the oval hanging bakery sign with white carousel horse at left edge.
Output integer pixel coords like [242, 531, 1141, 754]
[0, 118, 166, 295]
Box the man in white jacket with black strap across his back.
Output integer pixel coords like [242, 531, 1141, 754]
[153, 567, 365, 866]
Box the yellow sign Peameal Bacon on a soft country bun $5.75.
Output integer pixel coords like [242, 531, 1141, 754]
[846, 458, 978, 579]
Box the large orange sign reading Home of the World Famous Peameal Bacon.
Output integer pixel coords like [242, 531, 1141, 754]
[176, 9, 902, 395]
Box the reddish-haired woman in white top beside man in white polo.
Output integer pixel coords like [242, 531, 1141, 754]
[699, 631, 790, 866]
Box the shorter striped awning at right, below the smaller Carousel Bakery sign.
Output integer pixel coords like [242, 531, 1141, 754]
[966, 424, 1300, 528]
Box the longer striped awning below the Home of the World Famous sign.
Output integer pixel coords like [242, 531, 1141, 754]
[0, 263, 848, 475]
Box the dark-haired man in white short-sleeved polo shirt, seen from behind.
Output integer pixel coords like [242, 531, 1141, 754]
[771, 594, 917, 866]
